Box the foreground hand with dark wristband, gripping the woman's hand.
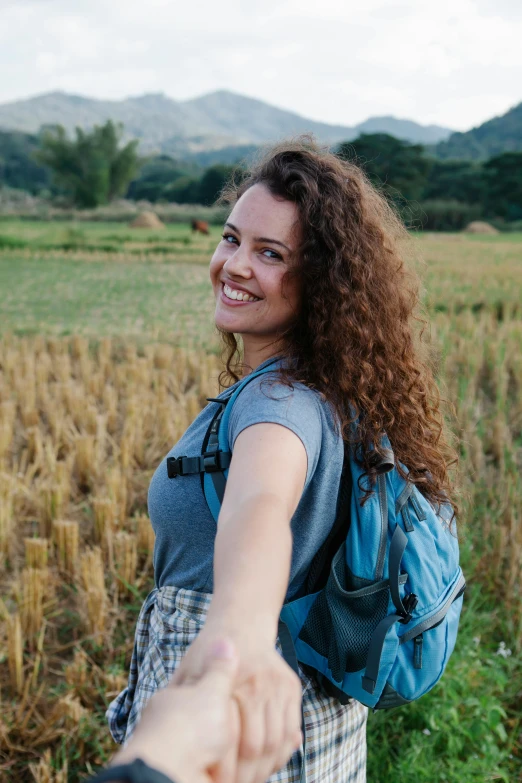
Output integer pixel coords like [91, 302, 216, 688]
[112, 638, 239, 783]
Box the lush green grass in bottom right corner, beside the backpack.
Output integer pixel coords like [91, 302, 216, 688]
[367, 540, 522, 783]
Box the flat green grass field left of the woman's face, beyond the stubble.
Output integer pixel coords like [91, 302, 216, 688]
[0, 220, 220, 349]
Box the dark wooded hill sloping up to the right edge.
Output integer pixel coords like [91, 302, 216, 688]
[434, 103, 522, 160]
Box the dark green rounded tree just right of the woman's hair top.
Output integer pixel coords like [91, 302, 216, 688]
[337, 133, 432, 202]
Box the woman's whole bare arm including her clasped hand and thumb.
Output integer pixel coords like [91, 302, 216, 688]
[175, 423, 307, 783]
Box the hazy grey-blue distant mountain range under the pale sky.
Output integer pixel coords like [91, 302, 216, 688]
[0, 90, 452, 159]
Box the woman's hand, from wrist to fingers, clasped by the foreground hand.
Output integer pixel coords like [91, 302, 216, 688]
[173, 626, 302, 783]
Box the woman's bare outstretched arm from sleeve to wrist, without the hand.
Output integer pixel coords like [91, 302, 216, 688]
[208, 423, 307, 644]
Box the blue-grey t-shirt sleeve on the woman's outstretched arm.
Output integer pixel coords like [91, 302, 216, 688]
[228, 376, 322, 489]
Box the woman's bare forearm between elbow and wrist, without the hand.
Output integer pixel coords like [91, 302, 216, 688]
[207, 495, 292, 641]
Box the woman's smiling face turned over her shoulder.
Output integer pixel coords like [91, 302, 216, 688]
[210, 184, 299, 367]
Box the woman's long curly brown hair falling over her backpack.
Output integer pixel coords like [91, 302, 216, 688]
[214, 136, 458, 514]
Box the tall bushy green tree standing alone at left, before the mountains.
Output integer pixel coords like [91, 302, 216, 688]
[36, 120, 139, 207]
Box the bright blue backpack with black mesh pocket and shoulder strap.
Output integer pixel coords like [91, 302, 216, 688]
[167, 360, 466, 710]
